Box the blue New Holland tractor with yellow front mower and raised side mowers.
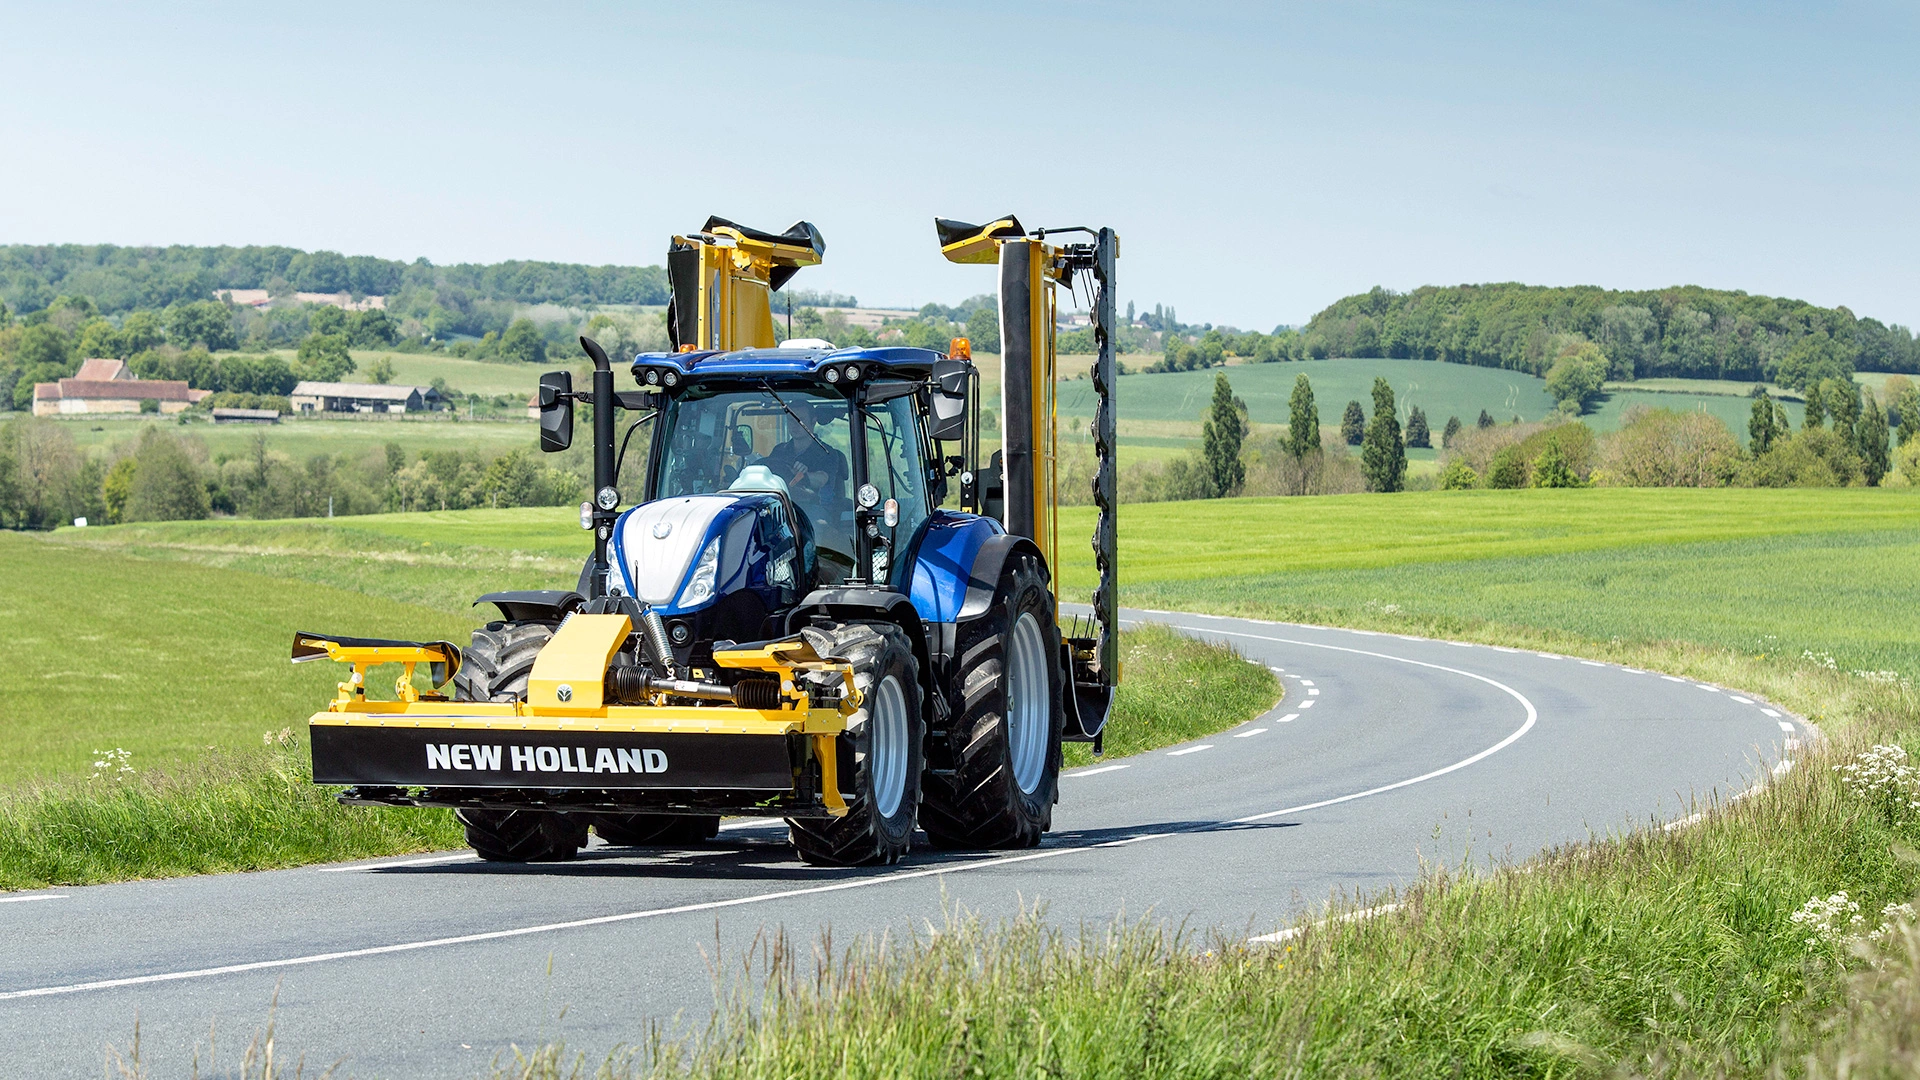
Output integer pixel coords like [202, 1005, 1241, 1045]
[294, 217, 1119, 865]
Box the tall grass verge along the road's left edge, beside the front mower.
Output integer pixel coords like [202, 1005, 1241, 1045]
[0, 728, 465, 892]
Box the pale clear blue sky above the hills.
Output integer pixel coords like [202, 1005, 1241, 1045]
[0, 0, 1920, 329]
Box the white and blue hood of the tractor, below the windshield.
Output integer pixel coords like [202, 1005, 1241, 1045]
[611, 492, 799, 613]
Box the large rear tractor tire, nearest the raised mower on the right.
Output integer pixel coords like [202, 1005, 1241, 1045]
[920, 555, 1066, 849]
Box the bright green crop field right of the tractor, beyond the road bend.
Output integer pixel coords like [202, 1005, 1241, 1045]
[1062, 488, 1920, 676]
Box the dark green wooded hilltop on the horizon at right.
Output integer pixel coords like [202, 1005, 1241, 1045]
[1300, 282, 1920, 386]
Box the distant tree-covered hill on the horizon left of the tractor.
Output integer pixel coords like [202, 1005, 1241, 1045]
[0, 244, 666, 315]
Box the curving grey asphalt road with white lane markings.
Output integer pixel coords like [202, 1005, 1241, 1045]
[0, 613, 1816, 1076]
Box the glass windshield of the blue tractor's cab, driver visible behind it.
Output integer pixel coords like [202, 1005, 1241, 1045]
[653, 386, 854, 584]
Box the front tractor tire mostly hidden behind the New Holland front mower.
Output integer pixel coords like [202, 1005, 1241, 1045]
[453, 623, 588, 863]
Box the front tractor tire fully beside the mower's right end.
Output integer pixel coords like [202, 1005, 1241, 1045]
[787, 623, 925, 867]
